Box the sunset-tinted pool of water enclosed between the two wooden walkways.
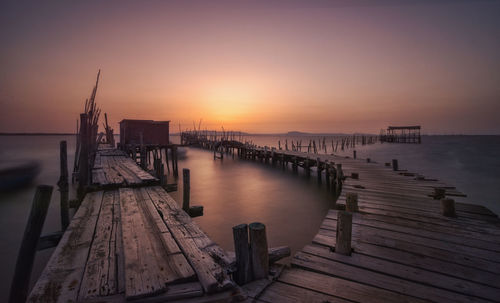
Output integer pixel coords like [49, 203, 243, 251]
[168, 148, 333, 253]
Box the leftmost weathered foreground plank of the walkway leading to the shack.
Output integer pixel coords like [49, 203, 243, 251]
[28, 191, 103, 302]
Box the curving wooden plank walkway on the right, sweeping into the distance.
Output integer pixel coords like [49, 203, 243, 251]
[248, 149, 500, 302]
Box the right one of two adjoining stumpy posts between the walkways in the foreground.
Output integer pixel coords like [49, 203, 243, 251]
[249, 222, 269, 280]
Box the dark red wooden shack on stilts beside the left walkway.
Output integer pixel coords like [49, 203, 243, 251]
[120, 119, 170, 146]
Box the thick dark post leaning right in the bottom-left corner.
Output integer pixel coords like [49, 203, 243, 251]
[9, 185, 53, 303]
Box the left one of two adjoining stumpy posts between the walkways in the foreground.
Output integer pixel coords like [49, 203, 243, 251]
[233, 224, 252, 285]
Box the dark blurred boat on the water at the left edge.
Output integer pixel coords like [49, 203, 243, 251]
[0, 161, 40, 192]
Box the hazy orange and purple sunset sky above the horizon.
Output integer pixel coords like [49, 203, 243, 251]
[0, 0, 500, 134]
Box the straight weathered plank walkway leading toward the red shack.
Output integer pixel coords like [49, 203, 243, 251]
[28, 148, 240, 302]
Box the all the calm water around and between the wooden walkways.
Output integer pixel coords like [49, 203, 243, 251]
[0, 136, 500, 302]
